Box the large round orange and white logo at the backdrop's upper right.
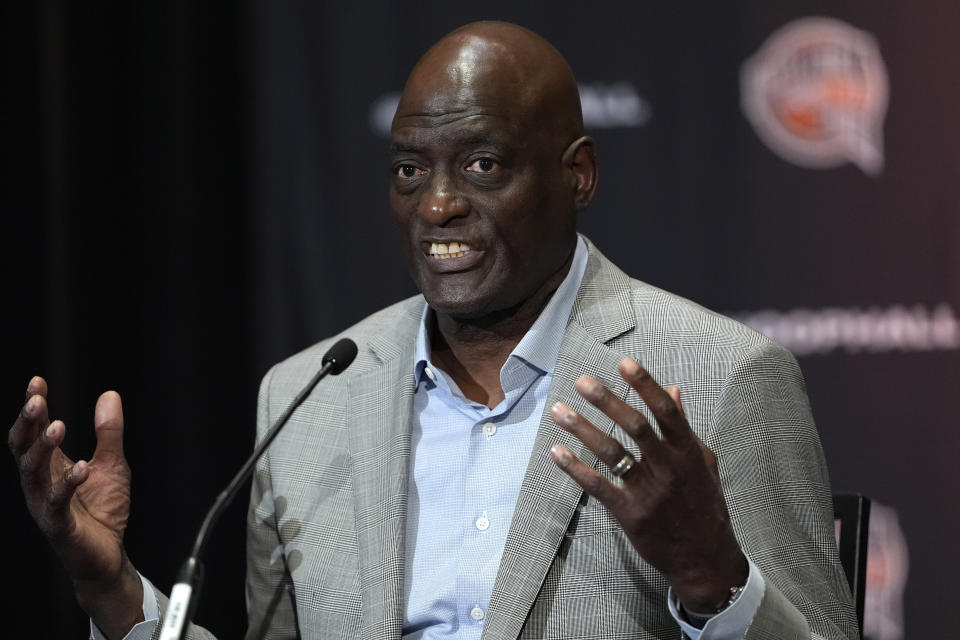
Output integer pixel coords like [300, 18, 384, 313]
[740, 17, 889, 176]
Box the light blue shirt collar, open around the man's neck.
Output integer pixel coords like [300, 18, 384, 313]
[413, 234, 587, 382]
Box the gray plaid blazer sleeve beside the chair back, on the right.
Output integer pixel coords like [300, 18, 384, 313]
[706, 340, 858, 640]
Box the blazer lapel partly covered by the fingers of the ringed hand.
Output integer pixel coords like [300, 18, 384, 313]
[483, 242, 635, 640]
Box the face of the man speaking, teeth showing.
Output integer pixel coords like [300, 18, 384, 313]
[390, 48, 576, 319]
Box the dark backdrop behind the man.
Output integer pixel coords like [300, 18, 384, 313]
[0, 0, 960, 638]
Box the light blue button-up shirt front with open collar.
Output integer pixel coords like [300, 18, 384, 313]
[403, 238, 587, 640]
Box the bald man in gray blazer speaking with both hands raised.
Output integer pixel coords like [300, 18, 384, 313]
[10, 22, 856, 640]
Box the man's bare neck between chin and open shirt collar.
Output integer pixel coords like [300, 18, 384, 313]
[428, 255, 573, 409]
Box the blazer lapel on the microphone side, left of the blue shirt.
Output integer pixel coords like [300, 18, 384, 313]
[347, 316, 419, 640]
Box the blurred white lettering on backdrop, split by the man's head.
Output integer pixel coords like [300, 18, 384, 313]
[369, 81, 653, 136]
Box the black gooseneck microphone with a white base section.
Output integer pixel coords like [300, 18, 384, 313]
[160, 338, 357, 640]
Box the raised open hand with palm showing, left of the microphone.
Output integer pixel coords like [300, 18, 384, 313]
[7, 377, 143, 638]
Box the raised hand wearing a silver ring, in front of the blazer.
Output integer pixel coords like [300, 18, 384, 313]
[551, 359, 748, 613]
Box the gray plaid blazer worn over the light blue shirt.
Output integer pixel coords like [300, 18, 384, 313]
[158, 243, 857, 640]
